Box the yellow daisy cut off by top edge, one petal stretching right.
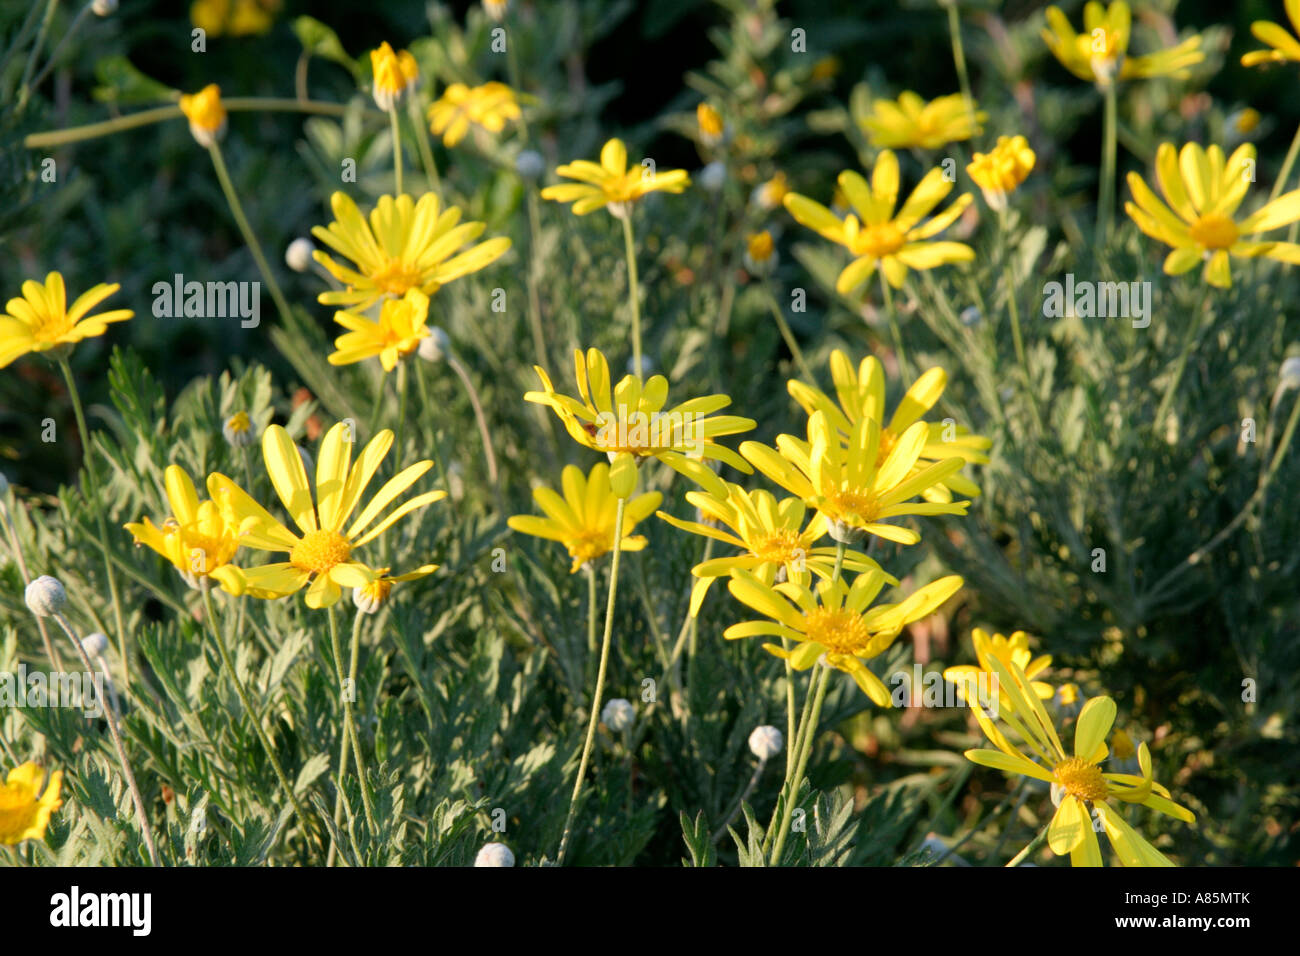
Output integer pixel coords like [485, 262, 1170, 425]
[1043, 0, 1205, 86]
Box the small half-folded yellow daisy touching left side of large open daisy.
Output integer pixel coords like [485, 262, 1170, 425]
[124, 464, 243, 594]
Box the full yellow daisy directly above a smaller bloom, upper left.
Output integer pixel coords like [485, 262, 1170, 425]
[312, 193, 510, 310]
